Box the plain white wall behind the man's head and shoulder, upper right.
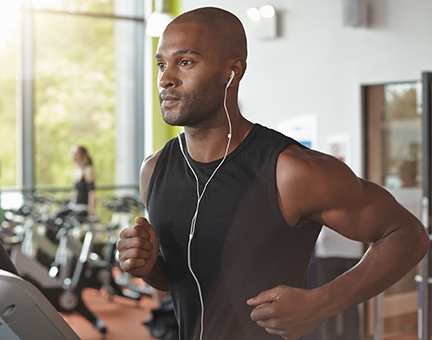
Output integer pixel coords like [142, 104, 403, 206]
[182, 0, 432, 175]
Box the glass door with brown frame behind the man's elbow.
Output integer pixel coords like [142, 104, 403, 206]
[362, 73, 432, 340]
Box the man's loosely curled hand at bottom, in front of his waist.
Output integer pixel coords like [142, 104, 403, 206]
[247, 286, 326, 340]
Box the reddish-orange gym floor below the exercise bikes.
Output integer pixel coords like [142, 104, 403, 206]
[63, 288, 157, 340]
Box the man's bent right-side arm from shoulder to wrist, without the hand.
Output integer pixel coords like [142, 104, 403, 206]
[277, 146, 429, 302]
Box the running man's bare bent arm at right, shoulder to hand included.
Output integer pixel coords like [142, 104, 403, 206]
[249, 146, 429, 339]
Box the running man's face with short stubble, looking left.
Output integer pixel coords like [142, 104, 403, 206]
[156, 23, 224, 127]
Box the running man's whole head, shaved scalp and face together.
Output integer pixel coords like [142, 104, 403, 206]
[155, 7, 247, 129]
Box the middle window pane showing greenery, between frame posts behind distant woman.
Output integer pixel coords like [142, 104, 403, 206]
[34, 13, 117, 186]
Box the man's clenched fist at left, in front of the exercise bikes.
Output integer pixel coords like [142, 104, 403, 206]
[117, 217, 159, 279]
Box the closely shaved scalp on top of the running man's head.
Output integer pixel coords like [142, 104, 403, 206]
[167, 7, 247, 60]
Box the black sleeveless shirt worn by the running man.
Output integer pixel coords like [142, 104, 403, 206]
[147, 124, 321, 340]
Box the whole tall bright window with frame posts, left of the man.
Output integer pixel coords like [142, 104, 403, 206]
[0, 0, 144, 211]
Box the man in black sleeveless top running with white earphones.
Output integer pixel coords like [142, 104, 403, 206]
[117, 8, 429, 340]
